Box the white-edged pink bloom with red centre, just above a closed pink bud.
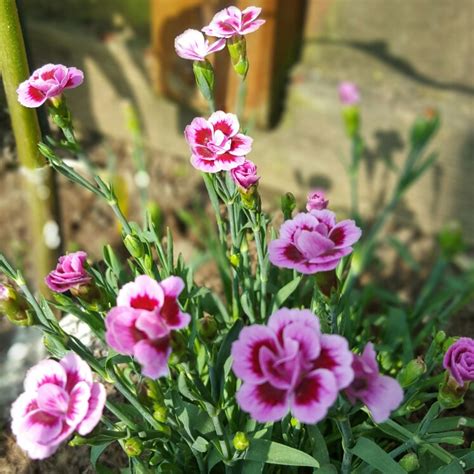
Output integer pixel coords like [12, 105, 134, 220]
[184, 110, 253, 173]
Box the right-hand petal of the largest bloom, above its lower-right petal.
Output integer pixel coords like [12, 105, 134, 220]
[313, 334, 354, 390]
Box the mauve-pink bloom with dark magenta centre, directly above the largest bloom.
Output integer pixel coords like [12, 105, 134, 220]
[268, 209, 361, 274]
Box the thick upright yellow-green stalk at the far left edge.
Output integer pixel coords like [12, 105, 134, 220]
[0, 0, 59, 291]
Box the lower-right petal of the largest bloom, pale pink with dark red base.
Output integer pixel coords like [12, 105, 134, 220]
[291, 369, 338, 424]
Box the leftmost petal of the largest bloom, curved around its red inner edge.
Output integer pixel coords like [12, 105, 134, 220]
[231, 324, 277, 383]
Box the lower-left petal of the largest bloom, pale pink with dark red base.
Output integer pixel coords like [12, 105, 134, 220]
[235, 382, 289, 423]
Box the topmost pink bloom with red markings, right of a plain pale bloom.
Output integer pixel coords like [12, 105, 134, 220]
[202, 7, 265, 38]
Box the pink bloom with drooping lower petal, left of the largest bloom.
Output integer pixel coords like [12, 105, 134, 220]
[105, 275, 191, 379]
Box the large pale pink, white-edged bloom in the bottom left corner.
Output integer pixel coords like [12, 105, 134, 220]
[11, 352, 106, 459]
